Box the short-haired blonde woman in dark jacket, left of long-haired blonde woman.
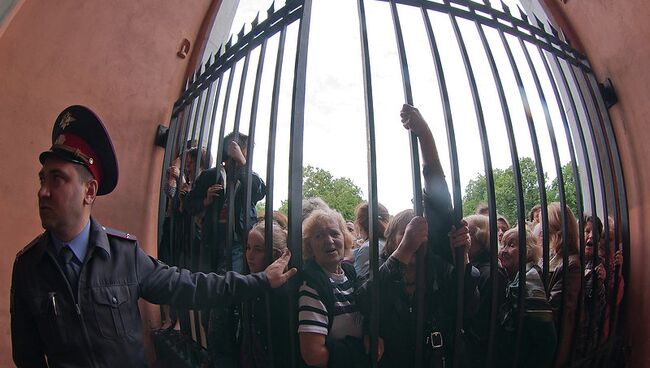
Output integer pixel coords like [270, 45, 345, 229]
[496, 227, 557, 368]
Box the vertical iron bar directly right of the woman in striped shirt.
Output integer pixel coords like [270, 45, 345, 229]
[357, 0, 379, 368]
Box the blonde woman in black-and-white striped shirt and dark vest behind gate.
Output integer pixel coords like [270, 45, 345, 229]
[298, 209, 368, 367]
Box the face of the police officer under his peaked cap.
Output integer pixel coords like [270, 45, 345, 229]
[38, 157, 94, 241]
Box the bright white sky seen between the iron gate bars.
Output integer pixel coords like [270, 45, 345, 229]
[197, 0, 569, 214]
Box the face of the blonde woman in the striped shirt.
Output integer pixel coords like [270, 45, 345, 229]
[309, 218, 345, 273]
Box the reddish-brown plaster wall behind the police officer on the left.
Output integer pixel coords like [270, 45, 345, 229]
[0, 0, 213, 367]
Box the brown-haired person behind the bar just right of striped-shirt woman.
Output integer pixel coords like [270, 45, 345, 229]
[354, 202, 390, 279]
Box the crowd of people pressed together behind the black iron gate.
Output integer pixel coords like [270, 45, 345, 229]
[153, 105, 623, 367]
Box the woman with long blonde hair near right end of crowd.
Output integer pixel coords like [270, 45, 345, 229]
[548, 202, 581, 367]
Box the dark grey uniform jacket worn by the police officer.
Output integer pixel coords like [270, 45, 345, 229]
[11, 219, 269, 367]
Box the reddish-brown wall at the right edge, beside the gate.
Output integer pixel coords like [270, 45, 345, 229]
[545, 0, 650, 367]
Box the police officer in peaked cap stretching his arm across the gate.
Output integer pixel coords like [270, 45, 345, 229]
[11, 106, 296, 367]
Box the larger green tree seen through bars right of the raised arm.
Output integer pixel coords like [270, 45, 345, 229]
[463, 157, 548, 225]
